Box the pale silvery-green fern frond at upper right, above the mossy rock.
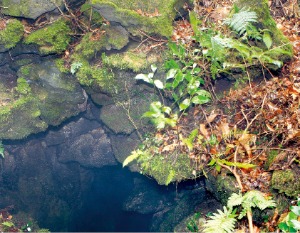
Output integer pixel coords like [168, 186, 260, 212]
[224, 8, 257, 35]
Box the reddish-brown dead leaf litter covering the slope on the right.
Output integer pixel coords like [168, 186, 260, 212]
[156, 0, 300, 231]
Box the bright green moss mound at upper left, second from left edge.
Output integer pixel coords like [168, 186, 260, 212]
[25, 19, 71, 55]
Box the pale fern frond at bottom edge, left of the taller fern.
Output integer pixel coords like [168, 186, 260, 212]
[203, 206, 236, 233]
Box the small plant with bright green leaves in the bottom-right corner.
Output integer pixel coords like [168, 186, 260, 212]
[278, 198, 300, 232]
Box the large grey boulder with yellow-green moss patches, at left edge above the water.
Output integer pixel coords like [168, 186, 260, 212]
[0, 61, 86, 139]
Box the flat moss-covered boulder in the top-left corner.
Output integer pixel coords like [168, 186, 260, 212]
[1, 0, 63, 19]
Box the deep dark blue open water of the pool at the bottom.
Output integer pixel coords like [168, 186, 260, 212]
[70, 166, 157, 232]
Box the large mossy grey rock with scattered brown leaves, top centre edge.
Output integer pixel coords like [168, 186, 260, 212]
[91, 0, 184, 36]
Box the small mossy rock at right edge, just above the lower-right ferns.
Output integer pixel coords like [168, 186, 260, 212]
[272, 170, 300, 198]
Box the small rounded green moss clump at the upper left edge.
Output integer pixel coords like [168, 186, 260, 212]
[0, 19, 24, 49]
